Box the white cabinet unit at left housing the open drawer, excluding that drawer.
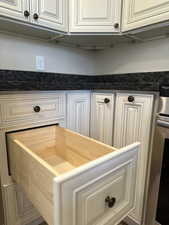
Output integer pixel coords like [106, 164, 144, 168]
[0, 91, 66, 225]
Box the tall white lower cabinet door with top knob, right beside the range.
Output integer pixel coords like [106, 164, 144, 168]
[114, 94, 153, 224]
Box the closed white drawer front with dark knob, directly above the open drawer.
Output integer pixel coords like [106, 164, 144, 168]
[1, 94, 65, 124]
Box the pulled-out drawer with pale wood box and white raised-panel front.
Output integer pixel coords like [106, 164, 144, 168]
[7, 126, 139, 225]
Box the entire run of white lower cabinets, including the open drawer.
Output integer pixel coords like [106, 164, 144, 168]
[0, 91, 153, 225]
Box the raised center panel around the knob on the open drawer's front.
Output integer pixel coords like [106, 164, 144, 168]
[76, 168, 128, 225]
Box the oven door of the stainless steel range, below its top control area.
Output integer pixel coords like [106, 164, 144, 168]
[145, 120, 169, 225]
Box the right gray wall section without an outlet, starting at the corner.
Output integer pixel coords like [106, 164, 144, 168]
[95, 39, 169, 74]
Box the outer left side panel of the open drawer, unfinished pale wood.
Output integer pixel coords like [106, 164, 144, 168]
[7, 137, 55, 225]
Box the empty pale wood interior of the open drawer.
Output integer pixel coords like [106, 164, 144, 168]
[8, 126, 116, 175]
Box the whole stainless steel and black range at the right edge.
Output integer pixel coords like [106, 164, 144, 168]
[145, 86, 169, 225]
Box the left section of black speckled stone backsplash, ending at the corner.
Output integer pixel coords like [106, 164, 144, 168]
[0, 70, 93, 91]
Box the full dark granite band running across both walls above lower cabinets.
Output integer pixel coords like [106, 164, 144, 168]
[0, 70, 169, 91]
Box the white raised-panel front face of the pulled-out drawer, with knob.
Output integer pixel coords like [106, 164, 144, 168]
[54, 145, 137, 225]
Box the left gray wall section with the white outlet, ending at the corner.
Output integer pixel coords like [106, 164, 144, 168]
[0, 34, 95, 75]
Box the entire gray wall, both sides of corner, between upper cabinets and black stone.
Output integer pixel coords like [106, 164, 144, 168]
[0, 34, 169, 75]
